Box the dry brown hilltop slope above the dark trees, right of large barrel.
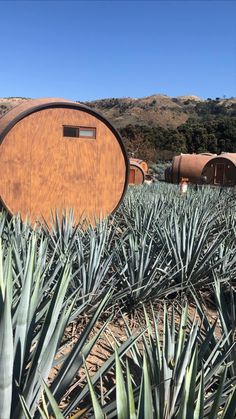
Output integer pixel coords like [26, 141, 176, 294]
[85, 95, 236, 128]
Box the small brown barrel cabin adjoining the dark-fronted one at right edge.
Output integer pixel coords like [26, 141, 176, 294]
[165, 153, 214, 184]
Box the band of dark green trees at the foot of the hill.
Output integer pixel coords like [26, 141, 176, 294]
[120, 115, 236, 160]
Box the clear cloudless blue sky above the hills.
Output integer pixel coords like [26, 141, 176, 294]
[0, 0, 236, 101]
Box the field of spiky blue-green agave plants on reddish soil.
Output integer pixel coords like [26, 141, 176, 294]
[0, 183, 236, 419]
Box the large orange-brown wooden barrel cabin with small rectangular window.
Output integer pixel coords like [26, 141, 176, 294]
[0, 98, 129, 224]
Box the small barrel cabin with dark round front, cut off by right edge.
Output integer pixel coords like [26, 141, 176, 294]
[202, 153, 236, 186]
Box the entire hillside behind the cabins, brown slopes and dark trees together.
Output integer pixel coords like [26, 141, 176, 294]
[0, 94, 236, 162]
